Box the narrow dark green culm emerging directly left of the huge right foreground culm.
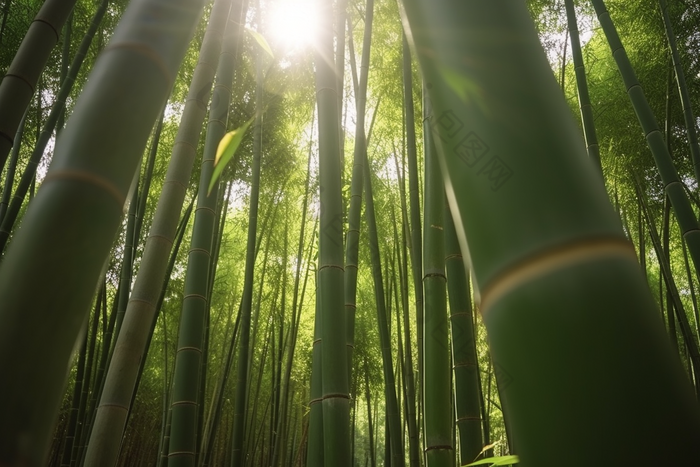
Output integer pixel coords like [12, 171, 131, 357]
[444, 205, 484, 465]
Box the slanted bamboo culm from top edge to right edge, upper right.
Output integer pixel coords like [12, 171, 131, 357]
[591, 0, 700, 278]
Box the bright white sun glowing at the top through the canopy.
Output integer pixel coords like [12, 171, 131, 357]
[266, 0, 318, 52]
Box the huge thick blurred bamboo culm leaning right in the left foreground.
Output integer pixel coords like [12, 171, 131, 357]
[0, 0, 203, 466]
